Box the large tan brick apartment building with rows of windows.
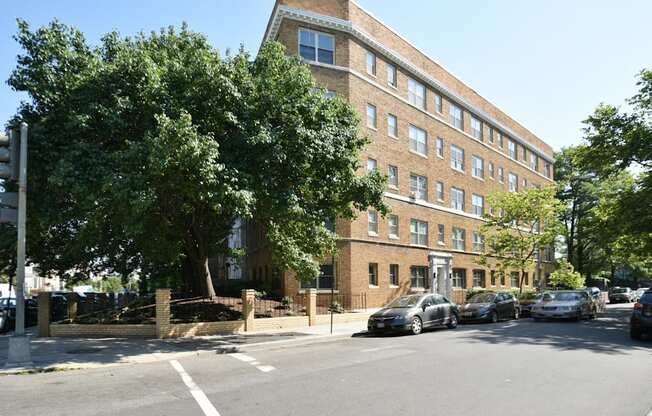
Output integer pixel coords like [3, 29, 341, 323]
[246, 0, 553, 305]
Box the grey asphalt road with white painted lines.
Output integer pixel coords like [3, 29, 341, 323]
[0, 305, 652, 416]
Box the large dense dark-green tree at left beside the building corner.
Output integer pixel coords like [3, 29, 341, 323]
[0, 21, 386, 296]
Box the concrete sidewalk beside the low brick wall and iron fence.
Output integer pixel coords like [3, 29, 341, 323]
[0, 321, 367, 375]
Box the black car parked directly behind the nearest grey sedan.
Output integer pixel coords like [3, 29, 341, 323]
[460, 292, 520, 323]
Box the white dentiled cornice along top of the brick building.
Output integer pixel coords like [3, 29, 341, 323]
[264, 5, 554, 163]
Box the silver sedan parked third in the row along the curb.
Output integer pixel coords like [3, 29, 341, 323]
[530, 290, 597, 321]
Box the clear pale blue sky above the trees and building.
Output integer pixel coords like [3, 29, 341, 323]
[0, 0, 652, 149]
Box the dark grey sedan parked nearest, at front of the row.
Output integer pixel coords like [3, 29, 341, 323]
[367, 293, 459, 335]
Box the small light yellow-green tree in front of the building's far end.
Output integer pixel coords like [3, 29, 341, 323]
[478, 186, 563, 292]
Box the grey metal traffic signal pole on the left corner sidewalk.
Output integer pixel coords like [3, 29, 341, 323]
[6, 123, 33, 367]
